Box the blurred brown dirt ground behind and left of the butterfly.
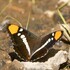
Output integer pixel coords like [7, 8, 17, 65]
[0, 0, 70, 70]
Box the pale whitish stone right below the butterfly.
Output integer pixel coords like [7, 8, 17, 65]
[21, 50, 68, 70]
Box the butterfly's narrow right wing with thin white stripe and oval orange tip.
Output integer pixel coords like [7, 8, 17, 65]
[31, 31, 63, 61]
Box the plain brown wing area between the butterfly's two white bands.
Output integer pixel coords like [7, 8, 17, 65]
[19, 29, 41, 54]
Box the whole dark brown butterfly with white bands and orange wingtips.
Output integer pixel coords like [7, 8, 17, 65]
[4, 24, 63, 61]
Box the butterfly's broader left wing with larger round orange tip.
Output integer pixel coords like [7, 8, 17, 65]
[7, 24, 38, 60]
